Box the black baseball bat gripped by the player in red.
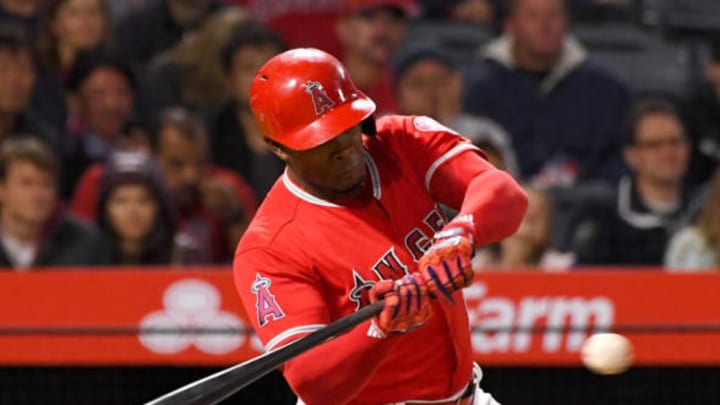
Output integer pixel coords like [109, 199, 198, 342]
[145, 300, 383, 405]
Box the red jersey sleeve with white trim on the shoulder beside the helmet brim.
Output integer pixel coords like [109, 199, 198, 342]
[378, 116, 485, 194]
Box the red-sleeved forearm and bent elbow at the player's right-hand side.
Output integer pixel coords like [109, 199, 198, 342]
[458, 170, 528, 246]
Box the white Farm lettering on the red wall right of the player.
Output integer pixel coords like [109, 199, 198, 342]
[464, 283, 615, 353]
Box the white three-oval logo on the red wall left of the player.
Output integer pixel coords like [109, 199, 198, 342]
[140, 279, 262, 355]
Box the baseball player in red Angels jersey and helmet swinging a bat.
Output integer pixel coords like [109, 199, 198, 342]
[234, 49, 527, 405]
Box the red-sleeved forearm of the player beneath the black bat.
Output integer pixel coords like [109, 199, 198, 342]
[284, 322, 397, 405]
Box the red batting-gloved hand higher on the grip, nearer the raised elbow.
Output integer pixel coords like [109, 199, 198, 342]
[418, 222, 475, 302]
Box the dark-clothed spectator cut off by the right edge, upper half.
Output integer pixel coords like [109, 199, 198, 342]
[684, 35, 720, 184]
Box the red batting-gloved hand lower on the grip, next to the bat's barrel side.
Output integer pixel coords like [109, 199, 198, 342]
[368, 273, 432, 338]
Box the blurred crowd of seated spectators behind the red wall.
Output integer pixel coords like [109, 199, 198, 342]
[0, 0, 720, 271]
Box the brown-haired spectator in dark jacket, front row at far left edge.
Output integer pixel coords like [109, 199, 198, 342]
[0, 138, 109, 270]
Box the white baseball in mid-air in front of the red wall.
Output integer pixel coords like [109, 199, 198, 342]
[581, 333, 633, 375]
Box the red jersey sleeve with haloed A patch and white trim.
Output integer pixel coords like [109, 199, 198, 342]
[233, 248, 329, 351]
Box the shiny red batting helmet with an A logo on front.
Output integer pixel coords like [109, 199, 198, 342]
[250, 48, 375, 150]
